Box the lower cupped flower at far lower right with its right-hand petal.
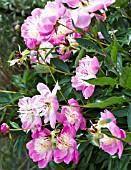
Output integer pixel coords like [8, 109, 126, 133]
[99, 123, 126, 158]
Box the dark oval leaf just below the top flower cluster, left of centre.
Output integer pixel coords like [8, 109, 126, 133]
[51, 58, 70, 72]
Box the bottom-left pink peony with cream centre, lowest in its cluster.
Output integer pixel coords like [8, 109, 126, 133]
[26, 128, 53, 168]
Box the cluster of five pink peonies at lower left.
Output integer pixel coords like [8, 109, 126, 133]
[18, 83, 86, 168]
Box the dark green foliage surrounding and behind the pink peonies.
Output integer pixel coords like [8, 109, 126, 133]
[0, 0, 131, 170]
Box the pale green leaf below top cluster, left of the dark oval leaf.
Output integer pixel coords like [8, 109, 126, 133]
[32, 64, 49, 73]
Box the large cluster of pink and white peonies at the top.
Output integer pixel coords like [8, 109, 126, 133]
[21, 0, 115, 63]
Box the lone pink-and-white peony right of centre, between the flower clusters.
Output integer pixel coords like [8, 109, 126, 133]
[71, 56, 100, 99]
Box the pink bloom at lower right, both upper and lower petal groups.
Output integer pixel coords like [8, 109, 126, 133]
[98, 110, 126, 158]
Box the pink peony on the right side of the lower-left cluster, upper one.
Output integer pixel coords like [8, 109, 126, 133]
[57, 99, 86, 131]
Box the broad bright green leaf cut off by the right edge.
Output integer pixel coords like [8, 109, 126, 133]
[120, 67, 131, 89]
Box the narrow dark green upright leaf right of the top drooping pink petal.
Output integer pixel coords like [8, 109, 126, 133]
[100, 20, 112, 42]
